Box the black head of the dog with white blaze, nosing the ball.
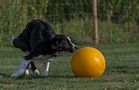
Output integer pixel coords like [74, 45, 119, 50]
[52, 35, 78, 53]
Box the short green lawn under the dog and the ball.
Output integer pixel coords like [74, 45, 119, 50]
[0, 43, 139, 90]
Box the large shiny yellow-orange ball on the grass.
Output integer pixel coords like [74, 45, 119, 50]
[71, 47, 106, 78]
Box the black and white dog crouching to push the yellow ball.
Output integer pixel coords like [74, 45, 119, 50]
[11, 19, 77, 77]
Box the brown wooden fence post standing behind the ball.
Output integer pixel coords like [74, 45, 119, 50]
[92, 0, 99, 44]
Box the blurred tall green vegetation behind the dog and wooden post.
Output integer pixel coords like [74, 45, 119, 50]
[0, 0, 139, 47]
